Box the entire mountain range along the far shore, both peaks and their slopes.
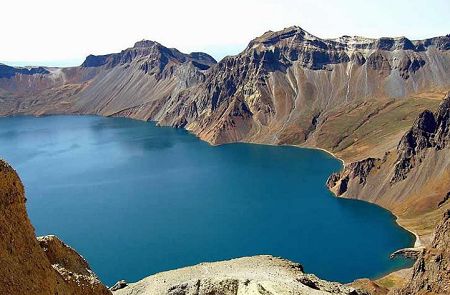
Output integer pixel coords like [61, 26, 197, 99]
[0, 27, 450, 158]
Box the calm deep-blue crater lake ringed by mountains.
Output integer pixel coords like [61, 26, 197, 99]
[0, 116, 414, 285]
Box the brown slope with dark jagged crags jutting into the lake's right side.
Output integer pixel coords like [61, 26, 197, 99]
[327, 94, 450, 242]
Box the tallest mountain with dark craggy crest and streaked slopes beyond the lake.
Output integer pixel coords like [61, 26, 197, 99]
[183, 27, 450, 149]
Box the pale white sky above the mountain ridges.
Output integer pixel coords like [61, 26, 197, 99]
[0, 0, 450, 66]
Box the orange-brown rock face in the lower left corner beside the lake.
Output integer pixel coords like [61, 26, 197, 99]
[0, 161, 110, 295]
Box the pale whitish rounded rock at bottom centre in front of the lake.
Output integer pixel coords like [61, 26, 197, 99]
[114, 255, 363, 295]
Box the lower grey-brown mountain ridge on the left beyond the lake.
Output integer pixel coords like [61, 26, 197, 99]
[0, 40, 216, 120]
